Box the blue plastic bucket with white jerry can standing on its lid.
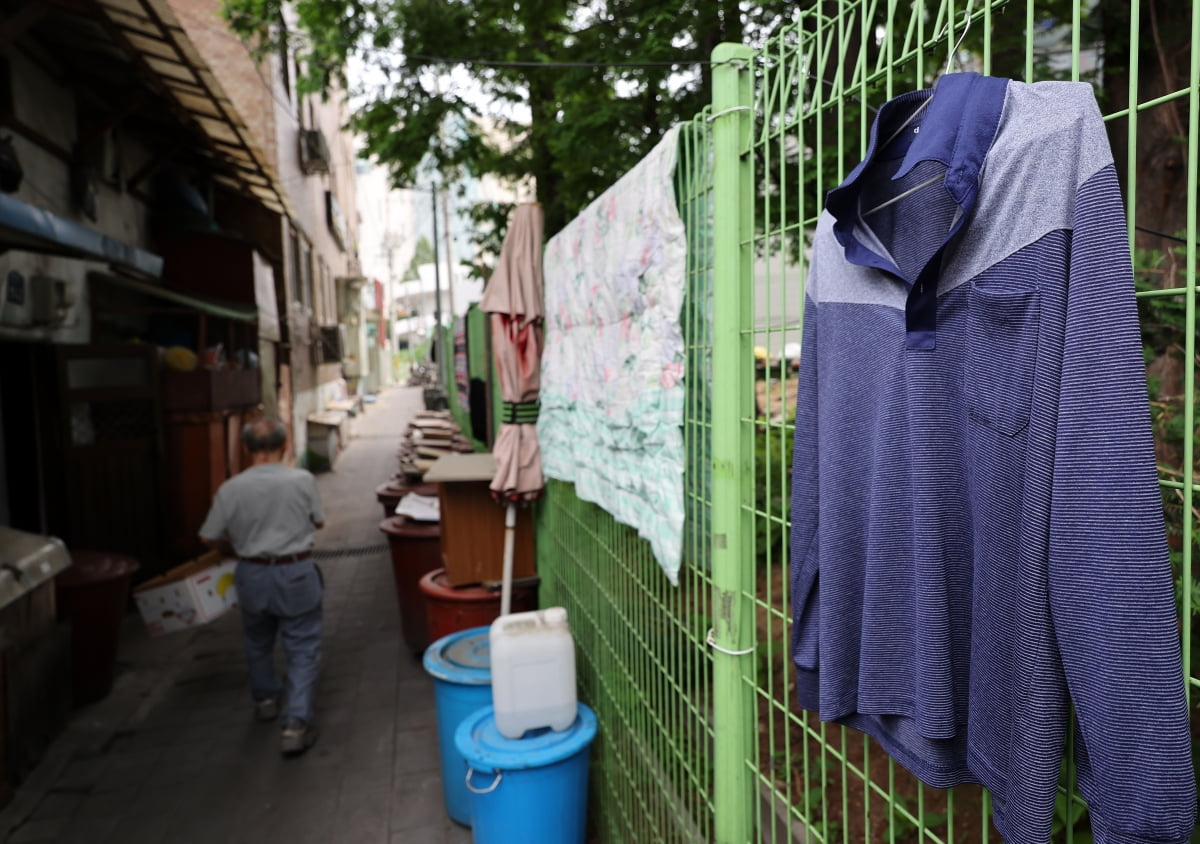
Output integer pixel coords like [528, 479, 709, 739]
[455, 704, 596, 844]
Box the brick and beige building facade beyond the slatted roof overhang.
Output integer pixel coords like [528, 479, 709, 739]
[170, 0, 364, 467]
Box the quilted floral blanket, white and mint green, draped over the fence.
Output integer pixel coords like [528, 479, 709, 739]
[538, 127, 686, 583]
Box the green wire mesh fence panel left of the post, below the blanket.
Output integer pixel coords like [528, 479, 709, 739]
[538, 115, 715, 842]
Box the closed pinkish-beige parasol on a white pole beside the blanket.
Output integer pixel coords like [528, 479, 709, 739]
[480, 203, 545, 615]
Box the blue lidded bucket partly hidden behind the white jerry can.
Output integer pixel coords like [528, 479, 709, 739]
[425, 627, 492, 826]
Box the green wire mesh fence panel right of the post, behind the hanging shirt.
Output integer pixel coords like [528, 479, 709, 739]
[734, 0, 1200, 844]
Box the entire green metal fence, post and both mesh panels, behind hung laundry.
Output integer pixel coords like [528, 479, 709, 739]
[538, 0, 1200, 844]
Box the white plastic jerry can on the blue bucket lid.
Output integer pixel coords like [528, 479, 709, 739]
[488, 606, 576, 738]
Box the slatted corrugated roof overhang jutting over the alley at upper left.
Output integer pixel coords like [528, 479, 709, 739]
[90, 0, 295, 217]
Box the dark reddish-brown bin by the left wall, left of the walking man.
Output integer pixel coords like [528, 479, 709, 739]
[54, 551, 140, 706]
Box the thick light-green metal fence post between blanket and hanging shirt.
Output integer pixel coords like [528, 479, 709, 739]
[712, 44, 756, 844]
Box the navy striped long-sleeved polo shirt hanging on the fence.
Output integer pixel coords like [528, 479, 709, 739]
[791, 73, 1196, 844]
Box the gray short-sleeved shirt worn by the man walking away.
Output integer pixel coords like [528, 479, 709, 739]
[200, 463, 325, 558]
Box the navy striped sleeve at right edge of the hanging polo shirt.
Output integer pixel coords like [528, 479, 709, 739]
[1049, 166, 1196, 844]
